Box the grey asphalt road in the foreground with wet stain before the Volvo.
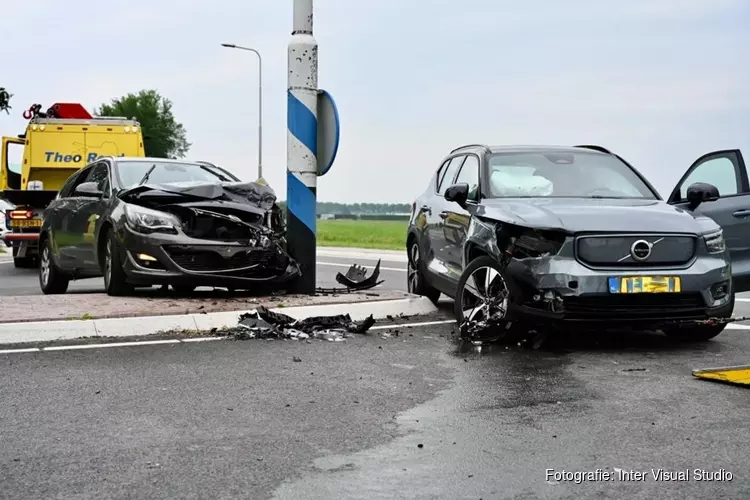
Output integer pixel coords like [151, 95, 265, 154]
[0, 314, 750, 500]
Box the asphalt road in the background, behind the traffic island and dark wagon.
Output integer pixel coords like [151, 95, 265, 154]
[0, 247, 406, 295]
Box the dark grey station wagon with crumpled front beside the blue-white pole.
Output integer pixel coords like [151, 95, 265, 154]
[39, 157, 300, 295]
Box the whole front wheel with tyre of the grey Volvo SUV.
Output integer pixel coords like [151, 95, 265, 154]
[454, 256, 515, 339]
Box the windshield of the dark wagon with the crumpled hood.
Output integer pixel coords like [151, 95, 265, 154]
[117, 161, 237, 189]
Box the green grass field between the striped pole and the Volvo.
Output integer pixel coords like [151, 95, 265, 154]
[317, 220, 407, 250]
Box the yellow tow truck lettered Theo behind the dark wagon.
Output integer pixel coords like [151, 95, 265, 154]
[0, 99, 145, 268]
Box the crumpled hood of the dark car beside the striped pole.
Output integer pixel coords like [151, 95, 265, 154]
[117, 182, 276, 210]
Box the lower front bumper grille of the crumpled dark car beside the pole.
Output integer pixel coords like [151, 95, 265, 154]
[164, 245, 279, 274]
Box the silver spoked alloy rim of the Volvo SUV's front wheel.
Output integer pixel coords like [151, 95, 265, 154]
[460, 266, 509, 321]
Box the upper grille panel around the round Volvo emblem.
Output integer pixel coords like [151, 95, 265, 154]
[576, 234, 697, 267]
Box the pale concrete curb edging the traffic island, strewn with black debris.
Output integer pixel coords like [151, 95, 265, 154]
[0, 296, 438, 344]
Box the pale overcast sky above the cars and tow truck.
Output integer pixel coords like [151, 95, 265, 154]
[0, 0, 750, 202]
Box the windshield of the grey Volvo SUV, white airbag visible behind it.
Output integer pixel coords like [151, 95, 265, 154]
[486, 151, 656, 199]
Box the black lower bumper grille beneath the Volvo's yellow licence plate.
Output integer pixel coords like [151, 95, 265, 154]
[563, 293, 705, 321]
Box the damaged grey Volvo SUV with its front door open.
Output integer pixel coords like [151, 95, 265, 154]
[407, 145, 750, 340]
